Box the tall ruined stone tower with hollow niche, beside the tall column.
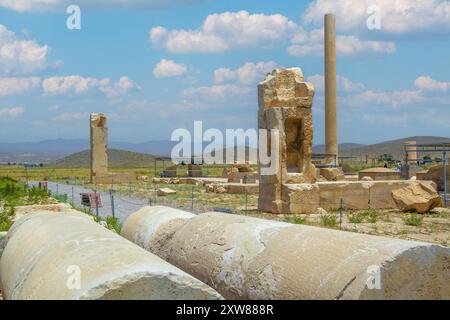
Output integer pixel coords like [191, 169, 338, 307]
[258, 68, 316, 213]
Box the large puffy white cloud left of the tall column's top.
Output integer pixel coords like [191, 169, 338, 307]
[149, 11, 298, 53]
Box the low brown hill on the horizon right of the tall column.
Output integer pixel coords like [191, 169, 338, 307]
[339, 136, 450, 160]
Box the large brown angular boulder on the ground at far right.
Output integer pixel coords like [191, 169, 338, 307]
[392, 182, 442, 213]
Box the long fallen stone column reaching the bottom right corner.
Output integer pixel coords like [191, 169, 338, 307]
[123, 207, 450, 299]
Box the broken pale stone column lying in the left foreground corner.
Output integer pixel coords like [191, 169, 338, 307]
[0, 212, 221, 300]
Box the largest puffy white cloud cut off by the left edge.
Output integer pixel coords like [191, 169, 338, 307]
[0, 24, 50, 74]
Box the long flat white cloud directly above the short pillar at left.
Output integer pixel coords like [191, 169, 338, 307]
[42, 75, 139, 98]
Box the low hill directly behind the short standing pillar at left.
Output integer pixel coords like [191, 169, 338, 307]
[48, 149, 170, 168]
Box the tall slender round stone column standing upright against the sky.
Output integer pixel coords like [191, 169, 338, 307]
[325, 14, 338, 164]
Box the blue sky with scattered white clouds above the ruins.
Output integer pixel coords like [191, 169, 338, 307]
[0, 0, 450, 144]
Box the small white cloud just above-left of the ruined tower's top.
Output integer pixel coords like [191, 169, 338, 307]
[214, 61, 277, 85]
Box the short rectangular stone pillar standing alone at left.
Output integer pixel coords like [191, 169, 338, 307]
[90, 113, 108, 183]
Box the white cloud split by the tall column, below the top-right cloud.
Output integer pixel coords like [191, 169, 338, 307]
[287, 28, 396, 57]
